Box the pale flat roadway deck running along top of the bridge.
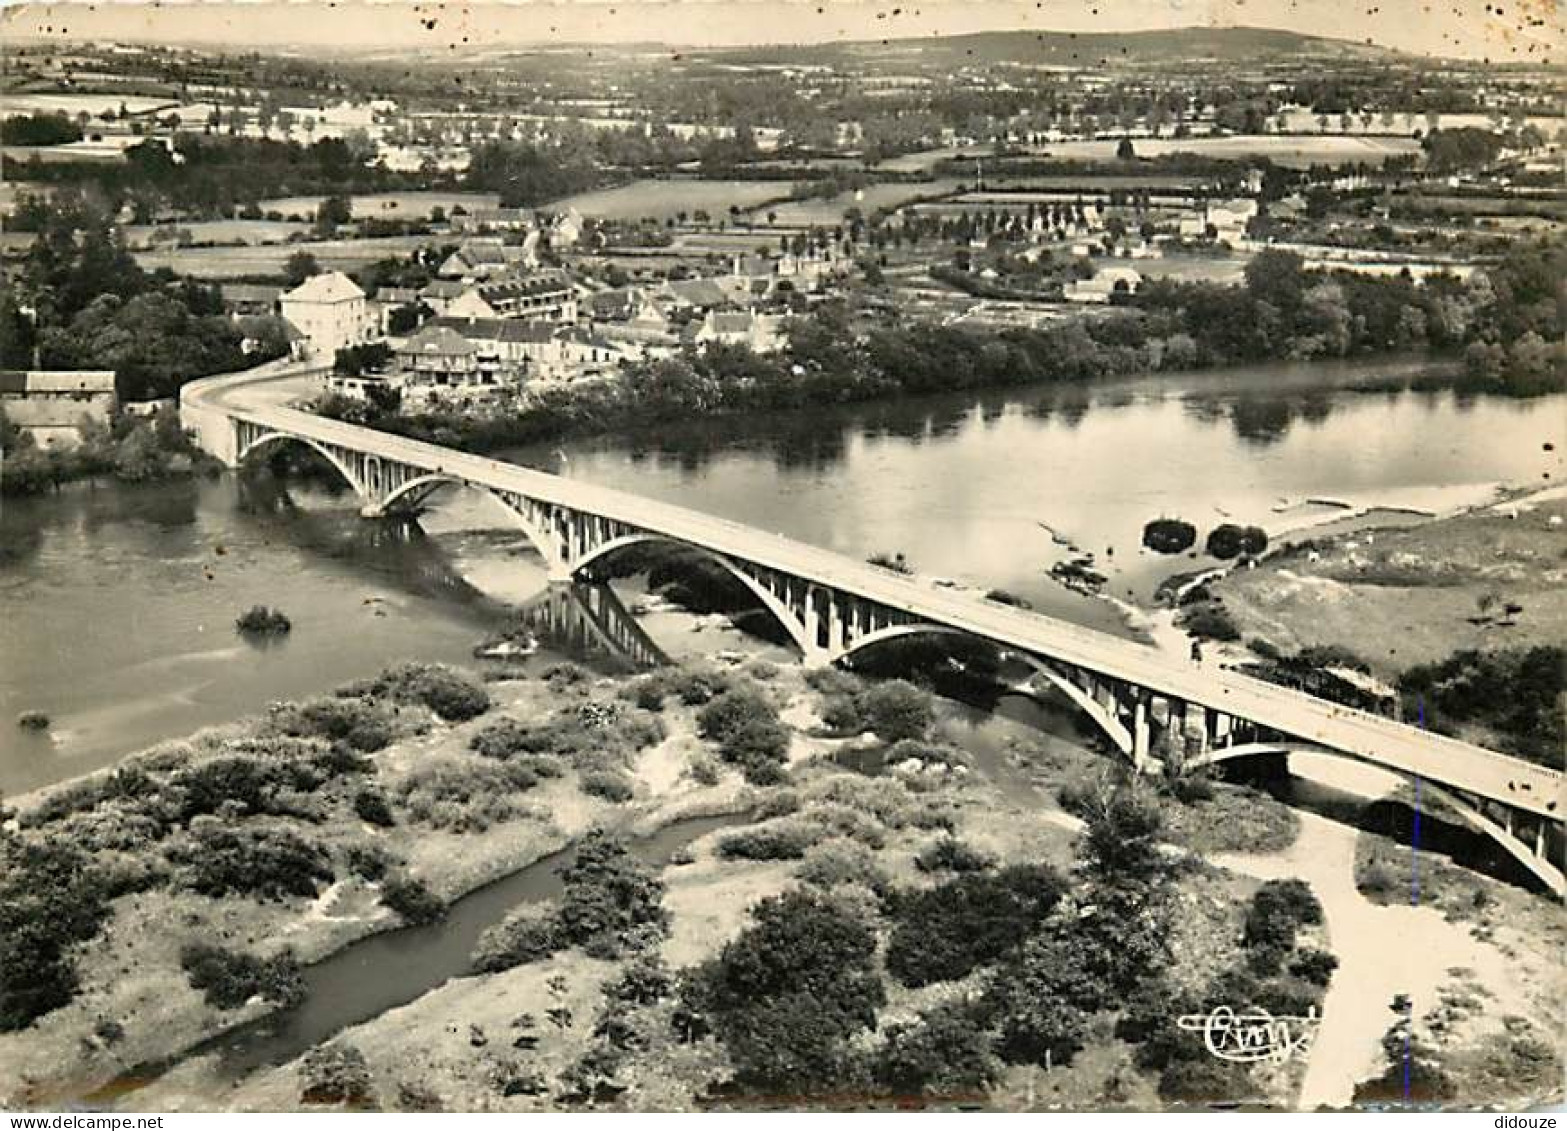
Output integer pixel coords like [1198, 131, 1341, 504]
[193, 369, 1562, 821]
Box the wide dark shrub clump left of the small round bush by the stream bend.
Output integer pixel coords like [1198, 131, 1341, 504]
[169, 818, 332, 899]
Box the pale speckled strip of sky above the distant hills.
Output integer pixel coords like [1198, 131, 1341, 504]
[0, 0, 1564, 63]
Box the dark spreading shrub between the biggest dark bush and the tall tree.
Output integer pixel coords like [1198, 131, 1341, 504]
[887, 865, 1064, 988]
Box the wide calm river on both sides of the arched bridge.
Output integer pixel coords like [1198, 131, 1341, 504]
[0, 354, 1567, 794]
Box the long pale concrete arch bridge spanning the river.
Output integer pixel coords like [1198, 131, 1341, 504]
[180, 364, 1567, 896]
